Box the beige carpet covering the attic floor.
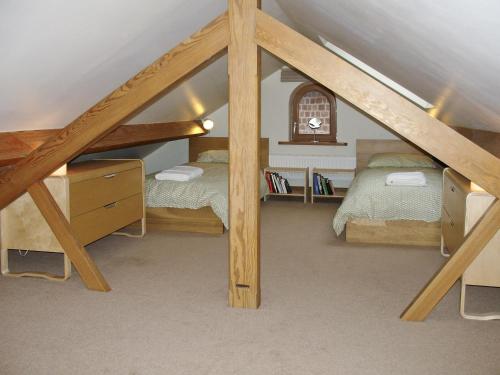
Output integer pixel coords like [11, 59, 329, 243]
[0, 201, 500, 375]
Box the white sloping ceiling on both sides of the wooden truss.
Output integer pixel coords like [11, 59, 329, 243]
[0, 0, 500, 135]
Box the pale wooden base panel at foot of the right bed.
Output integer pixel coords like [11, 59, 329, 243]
[346, 219, 441, 247]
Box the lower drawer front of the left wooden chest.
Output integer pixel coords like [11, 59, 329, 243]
[70, 193, 143, 245]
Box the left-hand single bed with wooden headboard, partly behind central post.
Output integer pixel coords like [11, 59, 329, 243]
[145, 137, 269, 234]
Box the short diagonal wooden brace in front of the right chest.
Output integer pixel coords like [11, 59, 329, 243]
[401, 199, 500, 321]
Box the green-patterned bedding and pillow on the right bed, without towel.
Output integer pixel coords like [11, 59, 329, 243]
[333, 168, 443, 235]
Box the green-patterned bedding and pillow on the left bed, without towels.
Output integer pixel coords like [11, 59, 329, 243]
[144, 163, 268, 229]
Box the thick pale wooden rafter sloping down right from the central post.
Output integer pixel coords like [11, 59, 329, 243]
[256, 11, 500, 197]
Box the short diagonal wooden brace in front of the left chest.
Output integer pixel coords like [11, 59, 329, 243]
[28, 181, 111, 292]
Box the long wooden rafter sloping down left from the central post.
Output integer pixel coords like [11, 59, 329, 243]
[0, 13, 229, 212]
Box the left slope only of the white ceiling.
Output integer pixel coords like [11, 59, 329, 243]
[0, 0, 290, 131]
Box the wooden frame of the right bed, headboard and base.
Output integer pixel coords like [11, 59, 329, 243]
[346, 139, 441, 247]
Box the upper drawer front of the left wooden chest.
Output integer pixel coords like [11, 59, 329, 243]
[69, 168, 142, 217]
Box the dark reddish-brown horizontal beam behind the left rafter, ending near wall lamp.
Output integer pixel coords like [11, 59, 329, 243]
[0, 121, 207, 167]
